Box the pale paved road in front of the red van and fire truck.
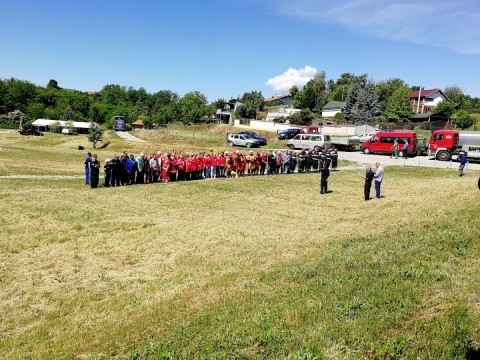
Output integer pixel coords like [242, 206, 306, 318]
[338, 151, 480, 171]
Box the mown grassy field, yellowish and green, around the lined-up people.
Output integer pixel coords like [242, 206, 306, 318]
[0, 129, 480, 359]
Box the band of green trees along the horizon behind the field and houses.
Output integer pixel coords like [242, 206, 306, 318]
[0, 71, 480, 128]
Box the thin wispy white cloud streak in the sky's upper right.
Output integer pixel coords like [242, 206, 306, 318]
[276, 0, 480, 54]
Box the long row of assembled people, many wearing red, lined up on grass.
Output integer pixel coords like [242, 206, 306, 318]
[84, 147, 338, 188]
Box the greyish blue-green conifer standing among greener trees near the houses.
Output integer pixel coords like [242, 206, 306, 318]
[343, 74, 380, 124]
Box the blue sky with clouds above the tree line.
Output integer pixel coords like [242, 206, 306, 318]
[0, 0, 480, 101]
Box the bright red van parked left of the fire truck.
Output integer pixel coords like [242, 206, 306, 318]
[362, 131, 417, 156]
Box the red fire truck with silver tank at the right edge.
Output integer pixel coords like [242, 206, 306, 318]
[428, 130, 480, 161]
